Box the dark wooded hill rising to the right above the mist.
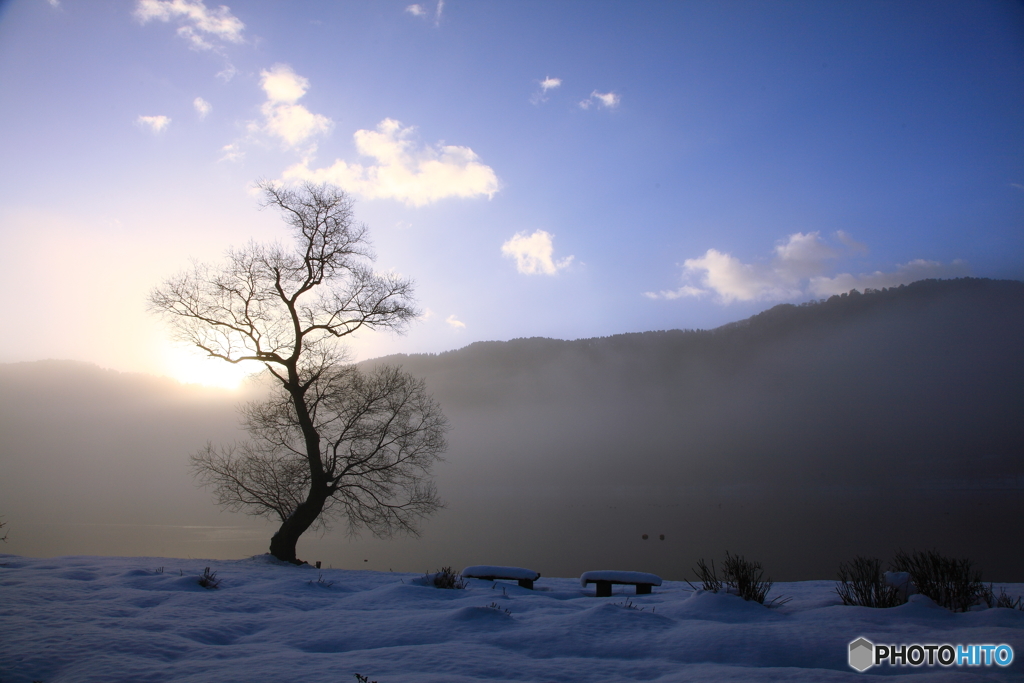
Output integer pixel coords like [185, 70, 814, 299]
[370, 279, 1024, 483]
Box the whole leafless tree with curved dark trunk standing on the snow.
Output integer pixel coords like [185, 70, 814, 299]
[150, 182, 446, 562]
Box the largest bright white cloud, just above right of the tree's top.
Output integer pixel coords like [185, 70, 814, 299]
[283, 119, 499, 206]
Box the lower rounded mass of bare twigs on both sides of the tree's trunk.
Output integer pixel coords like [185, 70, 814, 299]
[191, 366, 447, 536]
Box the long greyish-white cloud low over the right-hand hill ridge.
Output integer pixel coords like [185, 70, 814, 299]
[644, 231, 969, 304]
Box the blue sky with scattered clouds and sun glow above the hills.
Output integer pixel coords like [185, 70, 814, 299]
[0, 0, 1024, 384]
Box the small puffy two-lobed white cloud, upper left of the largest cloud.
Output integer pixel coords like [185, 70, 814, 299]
[258, 65, 334, 147]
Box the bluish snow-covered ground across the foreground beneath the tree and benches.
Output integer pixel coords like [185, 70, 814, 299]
[0, 555, 1024, 683]
